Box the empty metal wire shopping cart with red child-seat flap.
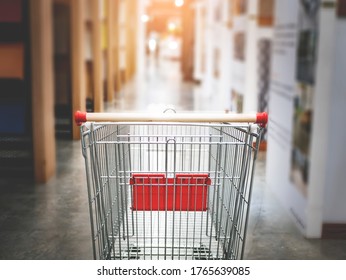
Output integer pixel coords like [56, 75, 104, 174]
[75, 112, 267, 260]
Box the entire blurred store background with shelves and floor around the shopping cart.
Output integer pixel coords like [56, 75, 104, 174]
[0, 0, 346, 259]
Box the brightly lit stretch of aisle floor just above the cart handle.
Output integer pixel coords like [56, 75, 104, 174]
[108, 57, 208, 112]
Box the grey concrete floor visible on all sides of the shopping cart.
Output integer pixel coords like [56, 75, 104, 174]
[0, 57, 346, 260]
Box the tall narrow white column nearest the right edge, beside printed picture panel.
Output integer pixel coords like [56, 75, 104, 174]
[306, 2, 336, 237]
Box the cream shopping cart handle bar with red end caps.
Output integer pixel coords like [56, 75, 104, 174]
[75, 111, 268, 127]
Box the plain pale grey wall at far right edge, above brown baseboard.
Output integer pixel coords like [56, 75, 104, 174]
[323, 13, 346, 223]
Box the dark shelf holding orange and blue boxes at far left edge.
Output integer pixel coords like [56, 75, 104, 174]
[0, 0, 34, 180]
